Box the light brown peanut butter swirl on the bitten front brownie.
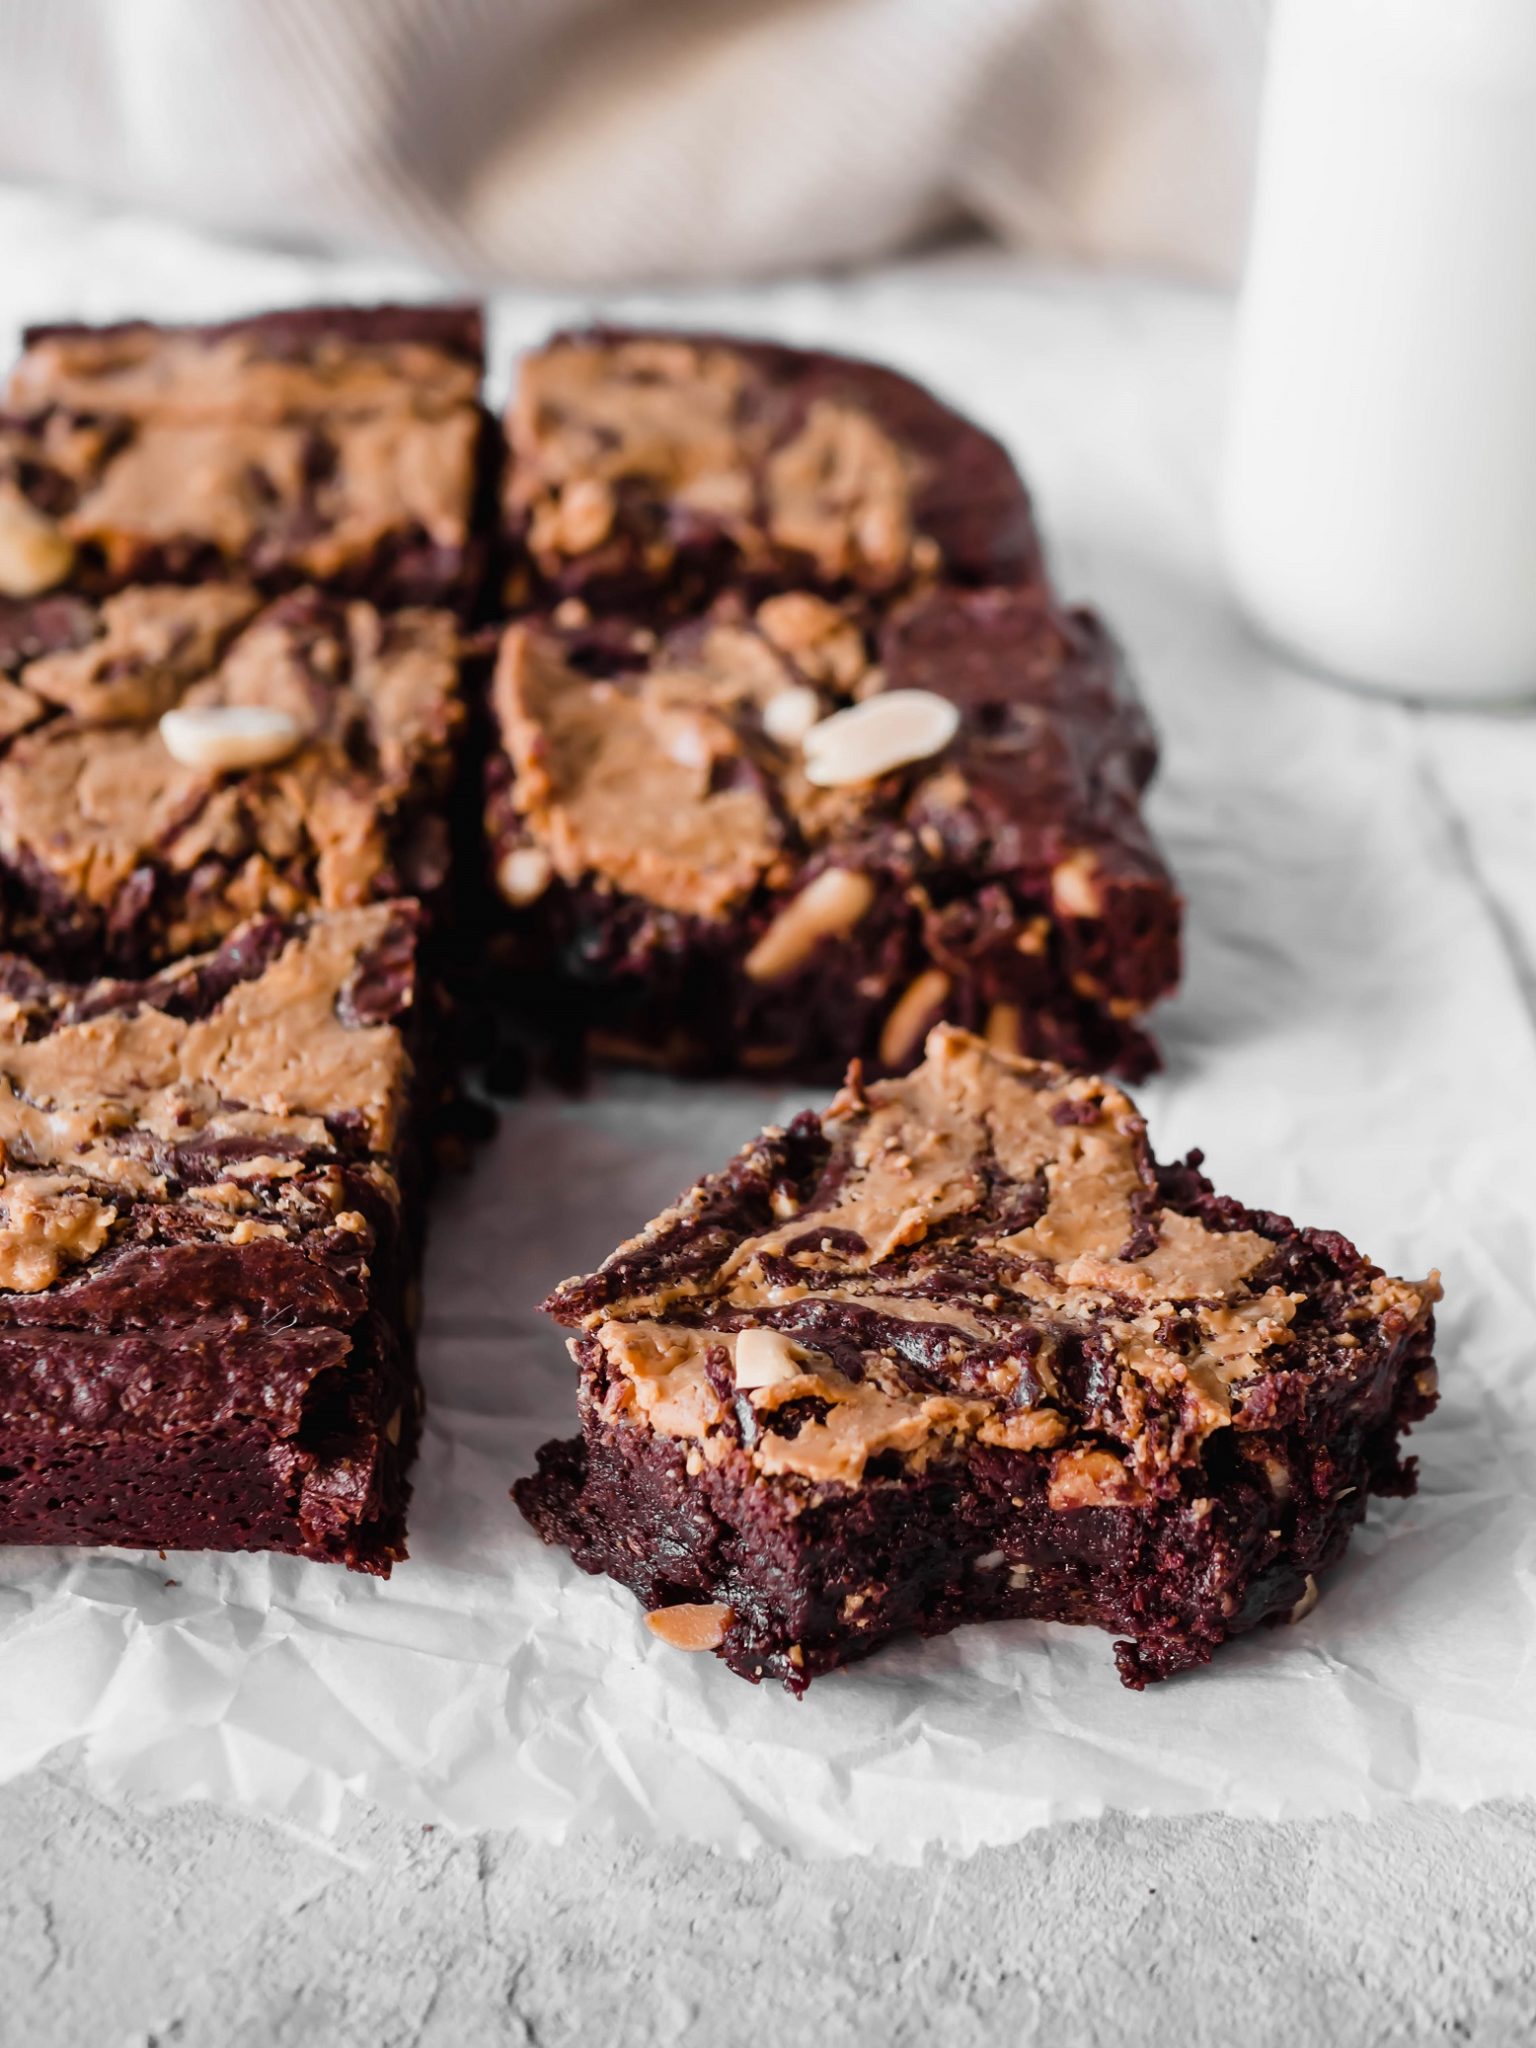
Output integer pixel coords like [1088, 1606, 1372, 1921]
[578, 1026, 1434, 1507]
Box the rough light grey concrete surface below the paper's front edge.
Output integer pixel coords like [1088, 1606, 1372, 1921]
[0, 1765, 1536, 2048]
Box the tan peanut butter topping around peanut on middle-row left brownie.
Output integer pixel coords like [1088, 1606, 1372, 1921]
[0, 584, 463, 954]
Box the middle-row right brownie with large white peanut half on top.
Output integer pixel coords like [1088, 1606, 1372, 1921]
[489, 590, 1180, 1077]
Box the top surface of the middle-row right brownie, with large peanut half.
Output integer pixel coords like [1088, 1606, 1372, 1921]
[494, 590, 1167, 925]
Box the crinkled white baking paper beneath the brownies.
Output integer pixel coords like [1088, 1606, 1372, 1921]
[0, 195, 1536, 1862]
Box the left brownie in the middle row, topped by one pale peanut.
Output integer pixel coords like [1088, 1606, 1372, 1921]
[0, 584, 463, 973]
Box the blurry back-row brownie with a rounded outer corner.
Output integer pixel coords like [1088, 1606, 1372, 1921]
[504, 328, 1040, 614]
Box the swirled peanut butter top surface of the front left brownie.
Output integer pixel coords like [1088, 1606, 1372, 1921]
[0, 903, 416, 1302]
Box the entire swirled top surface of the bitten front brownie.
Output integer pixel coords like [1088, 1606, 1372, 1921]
[547, 1026, 1438, 1507]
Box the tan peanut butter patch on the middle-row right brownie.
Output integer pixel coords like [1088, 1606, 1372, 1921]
[492, 590, 921, 921]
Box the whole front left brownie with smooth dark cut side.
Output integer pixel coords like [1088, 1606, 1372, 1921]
[0, 903, 420, 1573]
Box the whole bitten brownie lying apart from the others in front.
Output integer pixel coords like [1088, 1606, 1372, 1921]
[516, 1028, 1440, 1692]
